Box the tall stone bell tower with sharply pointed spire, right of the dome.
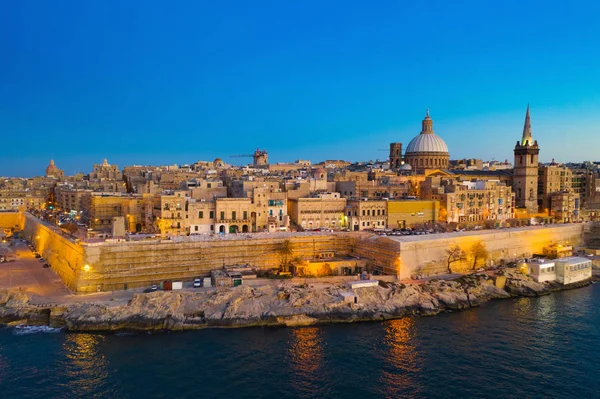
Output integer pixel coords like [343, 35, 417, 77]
[513, 104, 540, 213]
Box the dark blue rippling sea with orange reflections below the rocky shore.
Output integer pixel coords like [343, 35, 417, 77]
[0, 284, 600, 399]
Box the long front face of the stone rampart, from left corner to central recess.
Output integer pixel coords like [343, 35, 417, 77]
[78, 233, 353, 292]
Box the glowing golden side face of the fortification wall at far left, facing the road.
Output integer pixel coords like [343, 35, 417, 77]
[23, 213, 84, 291]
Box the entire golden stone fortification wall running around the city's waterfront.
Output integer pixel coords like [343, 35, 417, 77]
[17, 214, 584, 292]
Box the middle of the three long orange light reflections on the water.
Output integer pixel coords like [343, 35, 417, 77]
[289, 327, 324, 393]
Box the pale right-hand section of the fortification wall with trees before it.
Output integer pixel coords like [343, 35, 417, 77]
[384, 224, 584, 278]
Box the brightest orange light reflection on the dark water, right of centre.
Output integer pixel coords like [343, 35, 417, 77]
[380, 317, 422, 397]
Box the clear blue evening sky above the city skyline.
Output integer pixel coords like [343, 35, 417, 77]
[0, 0, 600, 176]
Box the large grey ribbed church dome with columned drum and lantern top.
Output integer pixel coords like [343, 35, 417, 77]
[404, 109, 450, 170]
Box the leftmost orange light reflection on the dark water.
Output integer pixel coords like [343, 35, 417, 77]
[63, 334, 110, 397]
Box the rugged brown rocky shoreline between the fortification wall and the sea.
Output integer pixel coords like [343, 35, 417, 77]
[0, 270, 598, 332]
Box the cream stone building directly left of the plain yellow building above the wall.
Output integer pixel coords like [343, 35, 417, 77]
[344, 199, 387, 231]
